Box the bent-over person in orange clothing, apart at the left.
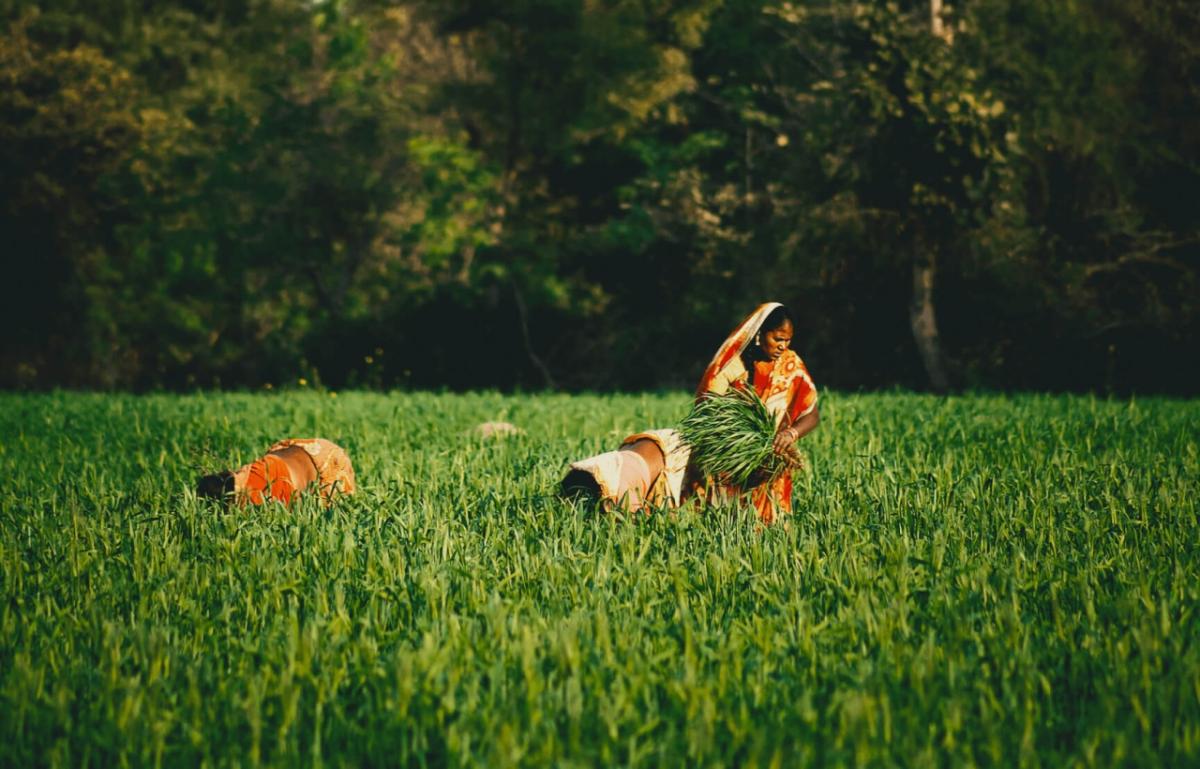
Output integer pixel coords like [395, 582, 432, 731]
[196, 438, 356, 505]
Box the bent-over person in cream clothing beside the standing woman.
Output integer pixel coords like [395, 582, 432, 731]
[560, 429, 691, 512]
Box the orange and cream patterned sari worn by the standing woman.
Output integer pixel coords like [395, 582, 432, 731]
[692, 302, 817, 523]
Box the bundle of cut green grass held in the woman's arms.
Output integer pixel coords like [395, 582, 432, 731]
[679, 387, 787, 486]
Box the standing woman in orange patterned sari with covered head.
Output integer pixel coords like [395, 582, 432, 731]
[692, 302, 821, 523]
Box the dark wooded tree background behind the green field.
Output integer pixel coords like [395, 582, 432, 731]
[0, 0, 1200, 386]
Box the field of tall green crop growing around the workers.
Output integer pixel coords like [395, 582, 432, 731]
[0, 390, 1200, 768]
